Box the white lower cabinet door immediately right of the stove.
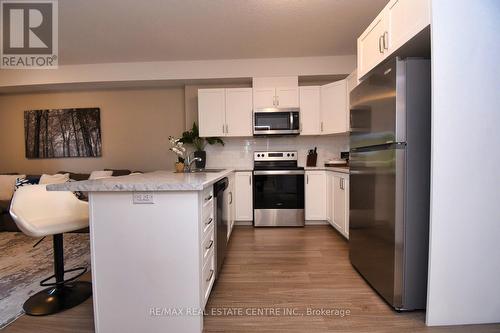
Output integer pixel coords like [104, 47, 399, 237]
[304, 171, 327, 221]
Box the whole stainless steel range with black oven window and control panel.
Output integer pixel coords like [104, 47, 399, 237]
[253, 151, 305, 227]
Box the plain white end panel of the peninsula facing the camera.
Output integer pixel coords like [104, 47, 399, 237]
[90, 191, 203, 333]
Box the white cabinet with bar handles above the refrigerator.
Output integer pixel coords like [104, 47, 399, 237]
[358, 0, 430, 79]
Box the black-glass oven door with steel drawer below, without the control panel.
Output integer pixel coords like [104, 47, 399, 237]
[253, 170, 304, 227]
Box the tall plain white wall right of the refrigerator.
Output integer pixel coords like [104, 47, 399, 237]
[427, 0, 500, 325]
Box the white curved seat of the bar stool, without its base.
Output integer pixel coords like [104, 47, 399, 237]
[10, 185, 89, 237]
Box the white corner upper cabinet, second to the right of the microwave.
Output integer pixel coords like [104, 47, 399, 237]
[320, 80, 349, 134]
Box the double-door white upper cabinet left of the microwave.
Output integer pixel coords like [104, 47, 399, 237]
[198, 88, 253, 137]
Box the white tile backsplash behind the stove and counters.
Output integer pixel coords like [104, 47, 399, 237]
[205, 134, 349, 169]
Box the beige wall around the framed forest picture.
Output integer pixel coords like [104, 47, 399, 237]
[0, 87, 185, 173]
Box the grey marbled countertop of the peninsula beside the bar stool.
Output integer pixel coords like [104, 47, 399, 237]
[47, 169, 234, 192]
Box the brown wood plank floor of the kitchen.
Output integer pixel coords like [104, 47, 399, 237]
[5, 226, 500, 333]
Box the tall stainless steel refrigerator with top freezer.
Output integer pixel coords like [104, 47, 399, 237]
[349, 58, 431, 310]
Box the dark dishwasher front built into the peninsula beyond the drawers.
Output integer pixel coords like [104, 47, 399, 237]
[214, 177, 229, 279]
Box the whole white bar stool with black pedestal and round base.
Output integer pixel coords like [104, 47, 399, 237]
[10, 185, 92, 316]
